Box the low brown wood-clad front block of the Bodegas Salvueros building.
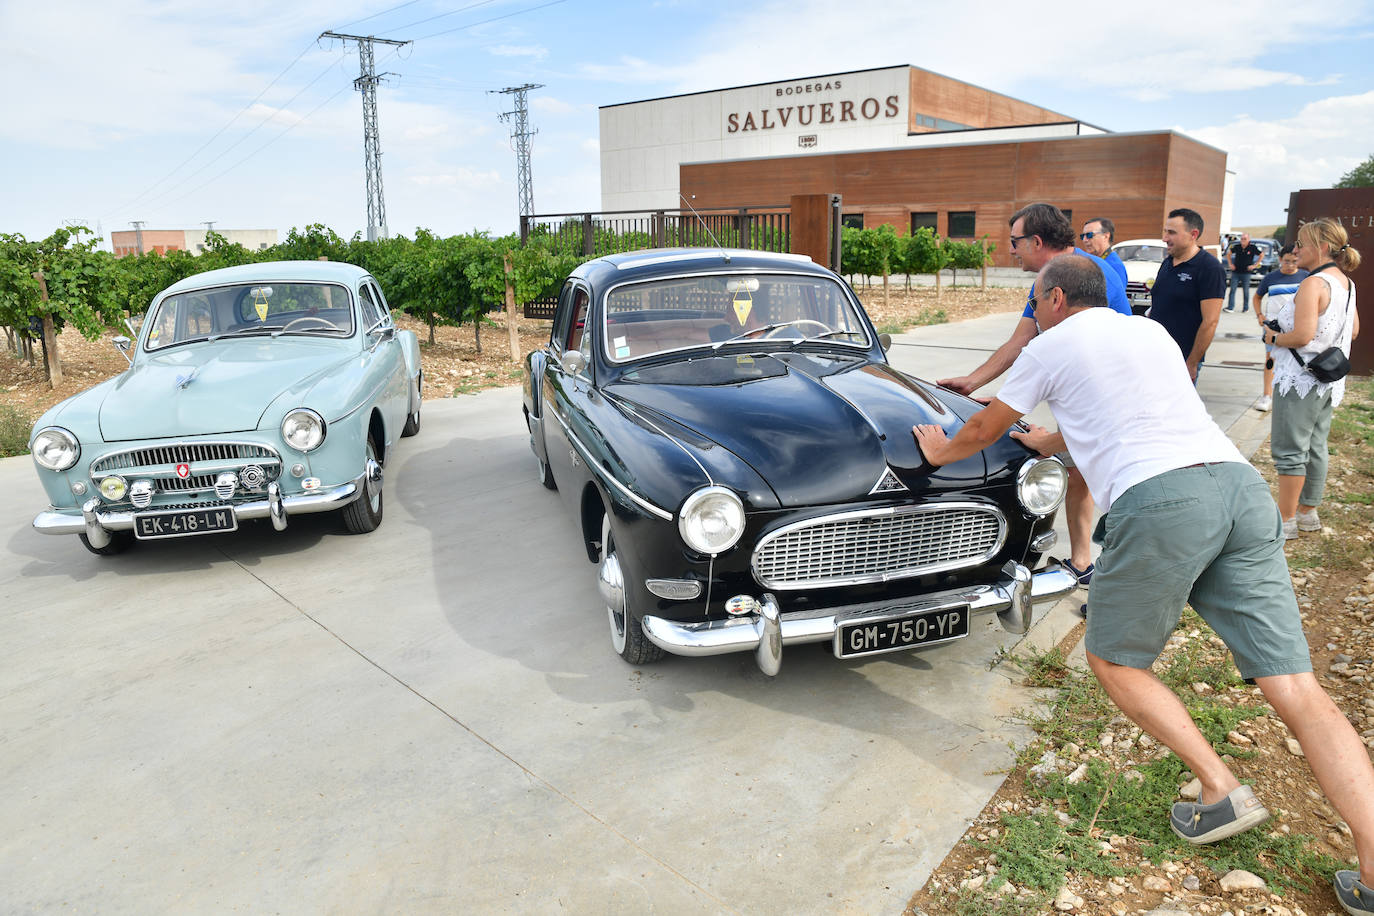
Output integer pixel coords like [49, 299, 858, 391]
[680, 132, 1226, 266]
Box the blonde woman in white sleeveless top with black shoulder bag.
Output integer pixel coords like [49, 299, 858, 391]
[1264, 218, 1360, 538]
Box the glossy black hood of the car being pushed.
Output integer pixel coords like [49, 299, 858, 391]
[607, 353, 987, 507]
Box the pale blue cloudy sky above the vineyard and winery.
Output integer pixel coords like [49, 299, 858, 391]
[0, 0, 1374, 247]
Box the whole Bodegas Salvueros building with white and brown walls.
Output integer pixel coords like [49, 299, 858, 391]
[599, 66, 1231, 266]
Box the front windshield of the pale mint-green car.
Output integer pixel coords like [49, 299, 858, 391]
[144, 283, 353, 350]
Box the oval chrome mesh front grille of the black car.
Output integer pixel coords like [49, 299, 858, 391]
[753, 503, 1007, 589]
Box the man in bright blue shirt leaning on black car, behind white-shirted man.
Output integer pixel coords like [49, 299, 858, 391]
[938, 203, 1131, 596]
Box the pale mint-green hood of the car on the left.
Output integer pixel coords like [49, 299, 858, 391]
[100, 336, 352, 442]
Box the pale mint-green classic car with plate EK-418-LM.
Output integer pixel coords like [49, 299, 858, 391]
[29, 261, 422, 555]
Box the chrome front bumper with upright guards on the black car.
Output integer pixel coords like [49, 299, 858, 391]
[640, 563, 1079, 674]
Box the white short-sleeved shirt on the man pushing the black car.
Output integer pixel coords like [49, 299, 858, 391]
[998, 308, 1245, 512]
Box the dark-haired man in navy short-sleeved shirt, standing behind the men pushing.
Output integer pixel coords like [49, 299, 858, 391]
[1149, 207, 1226, 385]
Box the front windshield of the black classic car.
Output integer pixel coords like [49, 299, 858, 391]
[605, 273, 870, 361]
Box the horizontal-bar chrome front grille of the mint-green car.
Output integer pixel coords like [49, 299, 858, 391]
[91, 442, 282, 499]
